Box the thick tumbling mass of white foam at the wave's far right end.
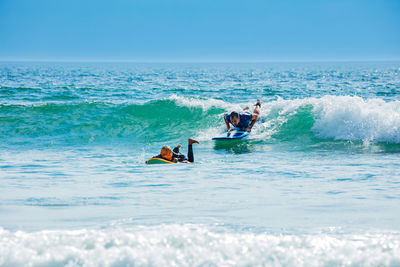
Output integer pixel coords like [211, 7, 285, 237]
[313, 96, 400, 143]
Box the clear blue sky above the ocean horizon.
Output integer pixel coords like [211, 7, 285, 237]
[0, 0, 400, 62]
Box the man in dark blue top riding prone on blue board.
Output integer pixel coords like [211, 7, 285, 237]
[224, 99, 261, 132]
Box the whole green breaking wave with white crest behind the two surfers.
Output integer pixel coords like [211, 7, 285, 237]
[0, 95, 400, 147]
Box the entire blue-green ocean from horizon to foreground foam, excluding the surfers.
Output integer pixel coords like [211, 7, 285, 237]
[0, 62, 400, 266]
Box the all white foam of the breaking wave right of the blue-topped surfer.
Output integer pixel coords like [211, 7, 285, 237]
[227, 96, 400, 144]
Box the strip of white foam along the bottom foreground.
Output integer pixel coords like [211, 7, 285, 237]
[0, 225, 400, 266]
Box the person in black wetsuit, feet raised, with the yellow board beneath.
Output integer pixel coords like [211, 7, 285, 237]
[146, 138, 199, 163]
